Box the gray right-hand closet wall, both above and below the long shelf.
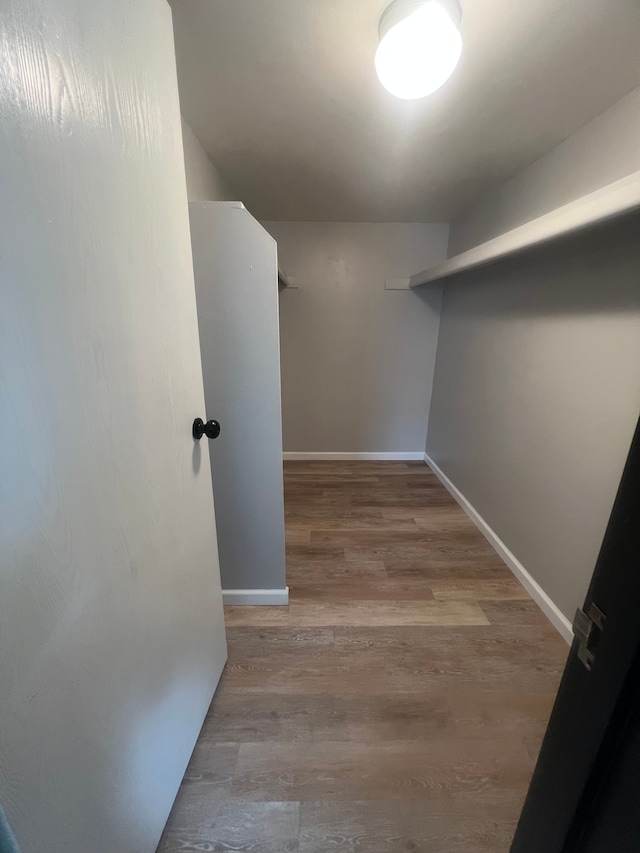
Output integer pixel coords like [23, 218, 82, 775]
[426, 85, 640, 618]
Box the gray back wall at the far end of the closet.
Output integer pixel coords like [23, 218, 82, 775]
[265, 222, 448, 452]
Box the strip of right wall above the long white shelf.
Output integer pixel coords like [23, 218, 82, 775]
[449, 88, 640, 256]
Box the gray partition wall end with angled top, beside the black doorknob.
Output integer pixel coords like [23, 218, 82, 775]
[189, 202, 286, 592]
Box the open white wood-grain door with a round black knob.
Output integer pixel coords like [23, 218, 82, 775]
[0, 0, 226, 853]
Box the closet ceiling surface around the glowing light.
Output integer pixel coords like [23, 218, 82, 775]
[170, 0, 640, 222]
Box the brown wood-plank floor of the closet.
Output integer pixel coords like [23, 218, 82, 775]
[159, 462, 568, 853]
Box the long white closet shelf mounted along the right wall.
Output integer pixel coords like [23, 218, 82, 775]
[409, 172, 640, 289]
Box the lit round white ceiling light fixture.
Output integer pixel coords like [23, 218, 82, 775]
[376, 0, 462, 100]
